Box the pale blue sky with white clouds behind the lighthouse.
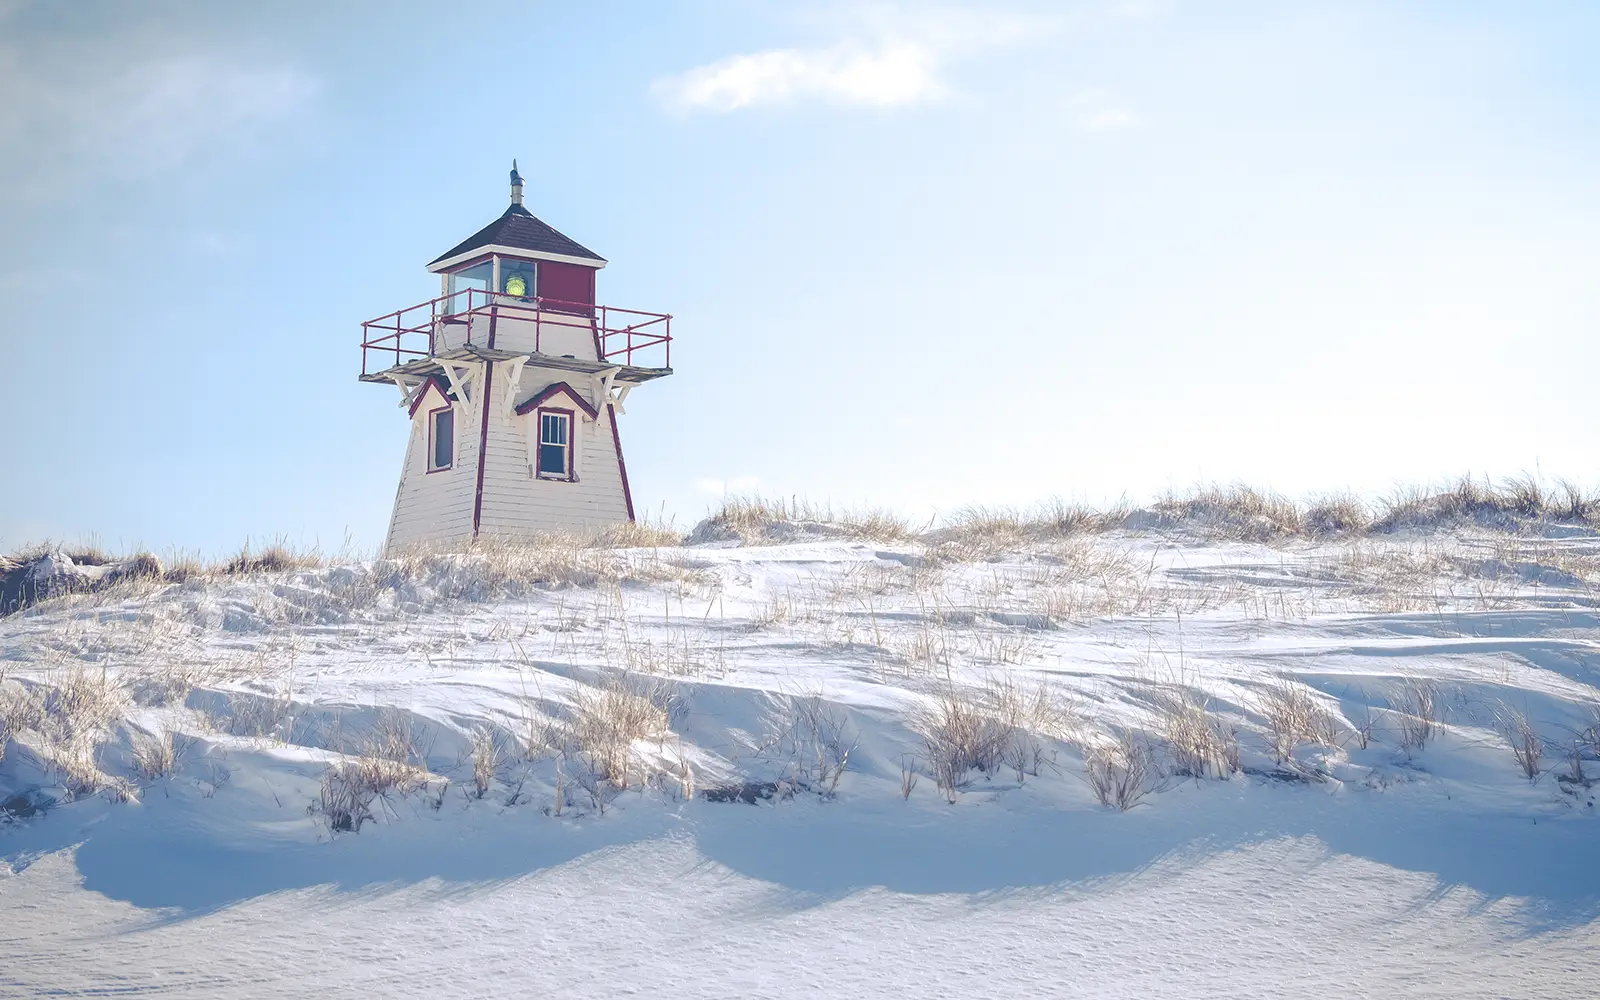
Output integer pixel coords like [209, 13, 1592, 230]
[0, 0, 1600, 554]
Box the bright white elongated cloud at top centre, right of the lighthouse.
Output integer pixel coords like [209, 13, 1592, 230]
[653, 6, 1042, 112]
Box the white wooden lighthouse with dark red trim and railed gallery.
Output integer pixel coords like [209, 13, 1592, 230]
[362, 162, 672, 550]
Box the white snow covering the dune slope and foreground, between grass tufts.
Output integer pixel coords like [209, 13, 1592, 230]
[0, 533, 1600, 997]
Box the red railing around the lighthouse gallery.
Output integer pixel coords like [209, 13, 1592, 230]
[362, 288, 672, 374]
